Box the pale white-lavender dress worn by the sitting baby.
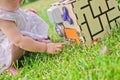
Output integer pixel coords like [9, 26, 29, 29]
[0, 9, 48, 73]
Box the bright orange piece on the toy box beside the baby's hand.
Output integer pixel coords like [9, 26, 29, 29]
[64, 28, 80, 43]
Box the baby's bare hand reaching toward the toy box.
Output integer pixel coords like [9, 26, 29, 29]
[46, 43, 65, 54]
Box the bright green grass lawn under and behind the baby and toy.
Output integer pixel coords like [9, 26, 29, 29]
[0, 0, 120, 80]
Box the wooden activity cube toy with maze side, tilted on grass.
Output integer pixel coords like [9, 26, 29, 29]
[47, 0, 120, 46]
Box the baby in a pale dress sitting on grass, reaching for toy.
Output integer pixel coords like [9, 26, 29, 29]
[0, 0, 65, 73]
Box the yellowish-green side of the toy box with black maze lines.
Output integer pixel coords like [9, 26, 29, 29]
[72, 0, 120, 44]
